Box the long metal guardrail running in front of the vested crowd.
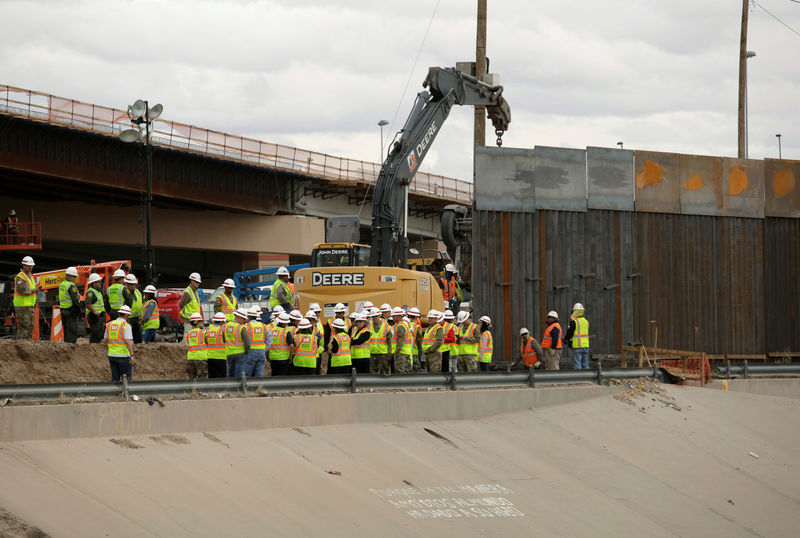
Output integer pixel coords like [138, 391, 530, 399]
[0, 368, 659, 401]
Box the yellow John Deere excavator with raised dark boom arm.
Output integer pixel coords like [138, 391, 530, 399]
[294, 67, 511, 318]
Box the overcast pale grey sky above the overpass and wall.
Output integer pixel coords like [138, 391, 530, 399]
[0, 0, 800, 179]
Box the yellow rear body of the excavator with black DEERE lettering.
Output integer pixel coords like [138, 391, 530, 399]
[294, 267, 445, 319]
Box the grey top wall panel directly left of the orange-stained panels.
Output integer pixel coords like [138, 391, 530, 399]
[586, 146, 634, 211]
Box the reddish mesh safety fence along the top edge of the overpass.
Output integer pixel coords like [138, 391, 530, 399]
[0, 84, 472, 204]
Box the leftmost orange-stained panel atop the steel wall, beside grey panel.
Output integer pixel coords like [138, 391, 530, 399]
[633, 151, 681, 213]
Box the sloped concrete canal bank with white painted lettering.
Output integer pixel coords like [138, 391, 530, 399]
[0, 384, 800, 537]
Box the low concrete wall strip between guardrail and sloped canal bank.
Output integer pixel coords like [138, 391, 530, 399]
[0, 386, 623, 442]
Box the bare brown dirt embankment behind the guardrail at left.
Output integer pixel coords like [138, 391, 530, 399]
[0, 340, 186, 385]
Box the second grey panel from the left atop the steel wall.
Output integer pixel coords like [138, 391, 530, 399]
[533, 146, 586, 211]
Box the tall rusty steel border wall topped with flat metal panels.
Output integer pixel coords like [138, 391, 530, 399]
[472, 147, 800, 360]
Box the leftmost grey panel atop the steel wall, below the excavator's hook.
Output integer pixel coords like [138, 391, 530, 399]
[475, 147, 535, 212]
